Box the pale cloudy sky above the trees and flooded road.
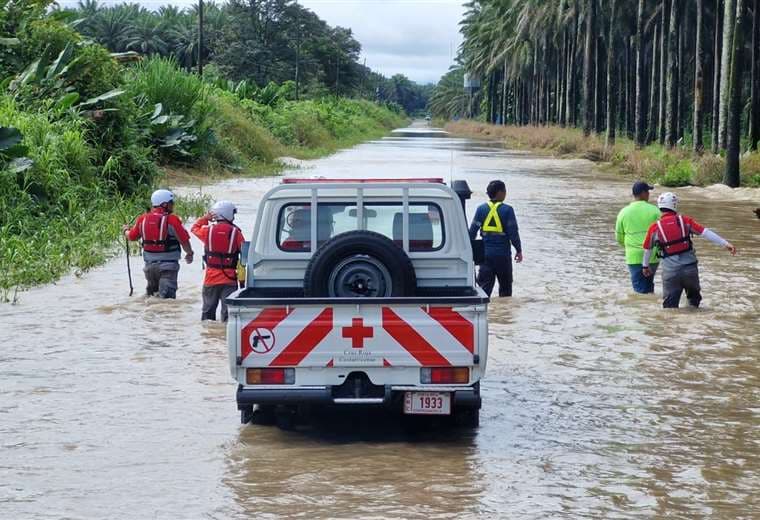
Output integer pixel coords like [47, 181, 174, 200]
[80, 0, 464, 83]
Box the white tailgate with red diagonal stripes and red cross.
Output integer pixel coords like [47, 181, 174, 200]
[228, 303, 487, 370]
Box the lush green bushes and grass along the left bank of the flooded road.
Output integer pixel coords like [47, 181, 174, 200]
[0, 0, 406, 300]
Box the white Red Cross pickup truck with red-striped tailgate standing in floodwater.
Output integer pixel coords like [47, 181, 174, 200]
[227, 179, 488, 427]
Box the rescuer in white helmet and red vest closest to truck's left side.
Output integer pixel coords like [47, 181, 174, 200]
[190, 200, 245, 321]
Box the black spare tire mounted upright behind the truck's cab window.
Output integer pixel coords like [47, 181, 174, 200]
[303, 231, 417, 298]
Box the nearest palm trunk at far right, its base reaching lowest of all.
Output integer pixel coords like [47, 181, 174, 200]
[723, 0, 746, 188]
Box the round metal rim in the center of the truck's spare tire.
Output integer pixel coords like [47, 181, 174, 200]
[328, 255, 393, 298]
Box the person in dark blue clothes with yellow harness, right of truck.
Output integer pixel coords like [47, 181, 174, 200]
[470, 180, 523, 296]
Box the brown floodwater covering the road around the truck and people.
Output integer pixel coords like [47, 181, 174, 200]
[0, 124, 760, 519]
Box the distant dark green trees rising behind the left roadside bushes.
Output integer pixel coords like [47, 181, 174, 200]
[56, 0, 430, 113]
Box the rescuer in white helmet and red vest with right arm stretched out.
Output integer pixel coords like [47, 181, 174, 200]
[642, 192, 736, 308]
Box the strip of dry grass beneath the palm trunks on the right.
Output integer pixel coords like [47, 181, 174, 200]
[437, 120, 760, 187]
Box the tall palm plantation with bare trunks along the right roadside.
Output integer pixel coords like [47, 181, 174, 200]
[442, 0, 760, 186]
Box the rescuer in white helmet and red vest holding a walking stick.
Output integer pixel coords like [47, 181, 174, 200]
[123, 190, 193, 298]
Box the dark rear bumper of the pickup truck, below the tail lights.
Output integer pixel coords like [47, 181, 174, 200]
[237, 383, 481, 410]
